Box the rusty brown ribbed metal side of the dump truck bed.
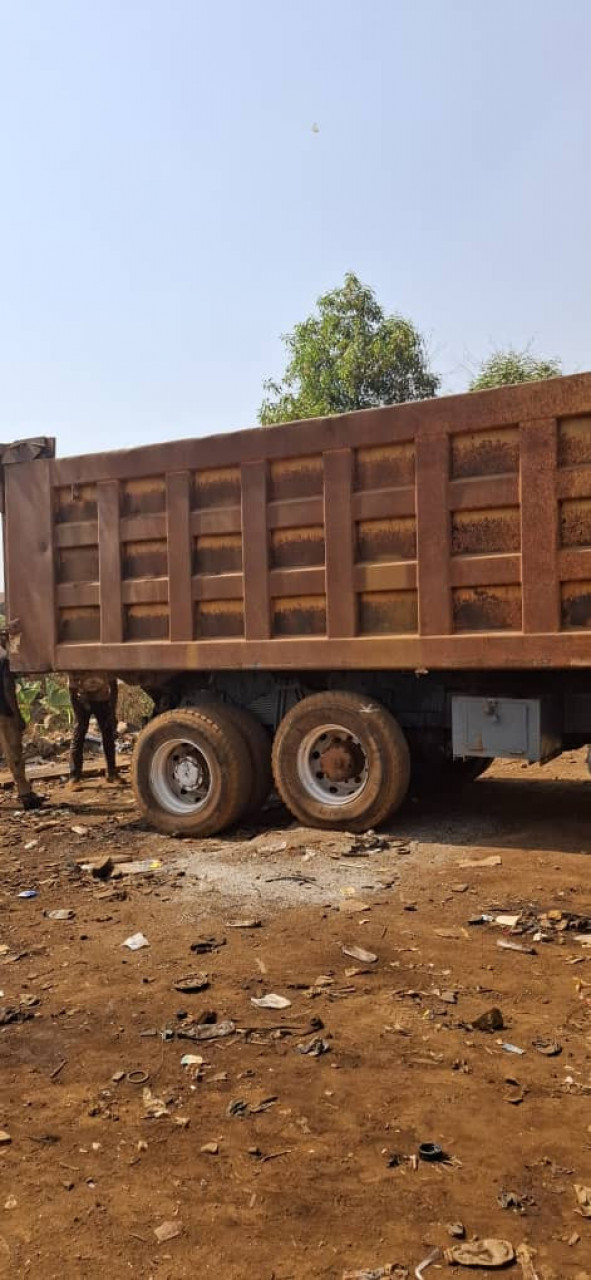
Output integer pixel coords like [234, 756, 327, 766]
[4, 374, 591, 672]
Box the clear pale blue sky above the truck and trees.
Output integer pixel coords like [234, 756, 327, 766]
[0, 0, 591, 454]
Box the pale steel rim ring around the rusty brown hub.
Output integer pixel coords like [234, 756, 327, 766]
[297, 724, 370, 809]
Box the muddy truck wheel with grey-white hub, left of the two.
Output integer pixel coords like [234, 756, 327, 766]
[133, 705, 252, 836]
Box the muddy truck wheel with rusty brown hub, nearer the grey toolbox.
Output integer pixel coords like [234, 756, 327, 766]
[272, 692, 411, 831]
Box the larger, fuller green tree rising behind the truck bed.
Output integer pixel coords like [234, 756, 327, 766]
[258, 273, 439, 426]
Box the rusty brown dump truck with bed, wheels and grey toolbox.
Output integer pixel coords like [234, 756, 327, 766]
[0, 374, 591, 836]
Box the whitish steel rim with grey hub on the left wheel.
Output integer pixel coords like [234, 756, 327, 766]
[150, 737, 216, 818]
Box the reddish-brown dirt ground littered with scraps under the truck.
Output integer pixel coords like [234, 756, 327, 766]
[0, 755, 591, 1280]
